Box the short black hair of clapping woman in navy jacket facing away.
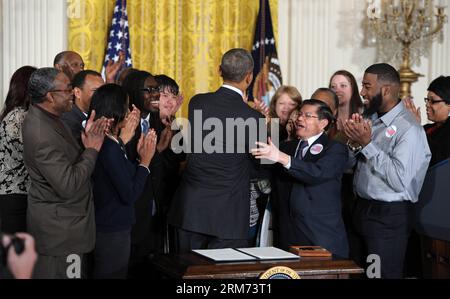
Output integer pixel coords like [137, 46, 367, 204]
[89, 84, 128, 127]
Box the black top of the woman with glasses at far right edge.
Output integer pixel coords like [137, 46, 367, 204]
[424, 117, 450, 166]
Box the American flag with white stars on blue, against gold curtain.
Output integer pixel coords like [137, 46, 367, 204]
[103, 0, 132, 76]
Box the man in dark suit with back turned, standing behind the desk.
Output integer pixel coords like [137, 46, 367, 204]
[168, 49, 263, 252]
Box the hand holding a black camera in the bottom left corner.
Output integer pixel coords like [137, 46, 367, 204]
[0, 233, 37, 279]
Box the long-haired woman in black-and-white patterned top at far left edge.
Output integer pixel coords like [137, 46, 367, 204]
[0, 66, 36, 234]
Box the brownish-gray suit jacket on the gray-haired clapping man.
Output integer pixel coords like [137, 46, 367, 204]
[22, 106, 97, 256]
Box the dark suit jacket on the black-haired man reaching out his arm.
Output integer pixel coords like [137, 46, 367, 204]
[273, 133, 348, 257]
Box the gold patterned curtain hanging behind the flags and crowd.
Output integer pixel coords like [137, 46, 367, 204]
[69, 0, 278, 117]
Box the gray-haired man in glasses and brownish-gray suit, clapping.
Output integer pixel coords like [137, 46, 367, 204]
[23, 68, 109, 278]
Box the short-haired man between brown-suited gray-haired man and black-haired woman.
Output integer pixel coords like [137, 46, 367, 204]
[61, 70, 105, 147]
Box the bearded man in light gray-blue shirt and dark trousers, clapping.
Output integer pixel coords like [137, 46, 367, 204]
[344, 63, 431, 278]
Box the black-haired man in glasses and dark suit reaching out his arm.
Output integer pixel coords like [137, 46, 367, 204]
[253, 100, 348, 257]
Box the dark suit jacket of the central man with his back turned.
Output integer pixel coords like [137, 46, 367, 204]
[168, 87, 262, 239]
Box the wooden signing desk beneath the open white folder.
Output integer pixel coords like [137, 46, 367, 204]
[153, 253, 364, 279]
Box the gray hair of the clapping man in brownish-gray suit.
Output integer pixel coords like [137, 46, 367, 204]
[28, 67, 60, 104]
